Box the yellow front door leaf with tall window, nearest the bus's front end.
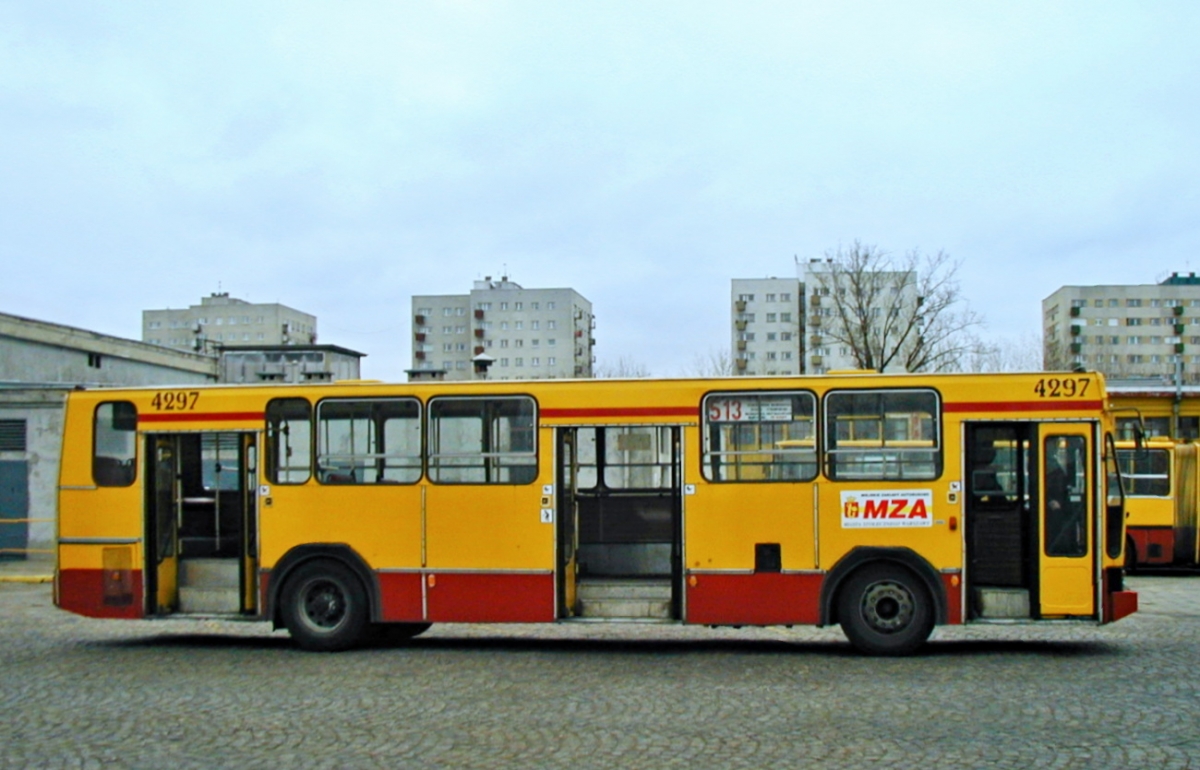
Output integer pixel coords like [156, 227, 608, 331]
[1036, 422, 1097, 618]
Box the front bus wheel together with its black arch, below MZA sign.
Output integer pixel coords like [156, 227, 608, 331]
[821, 547, 948, 655]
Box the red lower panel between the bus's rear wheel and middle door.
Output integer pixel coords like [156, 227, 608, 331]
[425, 572, 556, 622]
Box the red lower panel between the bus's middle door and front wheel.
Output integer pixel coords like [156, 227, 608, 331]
[688, 572, 824, 626]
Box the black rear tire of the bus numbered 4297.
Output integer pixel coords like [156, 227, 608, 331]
[282, 560, 371, 652]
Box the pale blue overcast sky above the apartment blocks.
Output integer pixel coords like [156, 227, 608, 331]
[0, 0, 1200, 380]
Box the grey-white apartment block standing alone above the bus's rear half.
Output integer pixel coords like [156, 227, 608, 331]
[409, 276, 595, 380]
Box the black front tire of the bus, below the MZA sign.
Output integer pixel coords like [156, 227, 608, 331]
[838, 564, 934, 655]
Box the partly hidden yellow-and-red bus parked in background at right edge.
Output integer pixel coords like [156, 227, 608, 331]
[1117, 439, 1200, 570]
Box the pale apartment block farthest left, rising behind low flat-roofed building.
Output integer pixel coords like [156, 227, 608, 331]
[142, 291, 317, 353]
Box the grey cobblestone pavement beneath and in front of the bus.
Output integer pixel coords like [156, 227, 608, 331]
[0, 577, 1200, 770]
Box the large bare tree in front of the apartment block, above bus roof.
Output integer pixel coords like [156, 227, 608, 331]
[810, 241, 982, 372]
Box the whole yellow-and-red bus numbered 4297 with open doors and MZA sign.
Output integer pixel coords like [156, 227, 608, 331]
[55, 373, 1136, 655]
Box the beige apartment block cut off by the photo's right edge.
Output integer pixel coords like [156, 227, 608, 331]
[1042, 272, 1200, 384]
